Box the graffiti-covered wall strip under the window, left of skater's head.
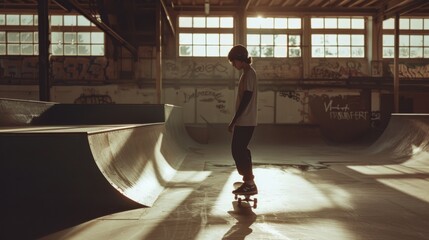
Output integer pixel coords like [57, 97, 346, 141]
[164, 59, 233, 80]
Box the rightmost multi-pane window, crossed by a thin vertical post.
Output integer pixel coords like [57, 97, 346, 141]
[383, 18, 429, 58]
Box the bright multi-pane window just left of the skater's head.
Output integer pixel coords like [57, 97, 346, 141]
[179, 16, 234, 57]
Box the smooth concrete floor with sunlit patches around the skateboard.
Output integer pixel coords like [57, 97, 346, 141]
[42, 125, 429, 240]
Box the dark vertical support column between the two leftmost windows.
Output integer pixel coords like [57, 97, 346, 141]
[37, 0, 50, 101]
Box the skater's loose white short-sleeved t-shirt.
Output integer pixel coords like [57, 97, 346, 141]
[235, 66, 258, 126]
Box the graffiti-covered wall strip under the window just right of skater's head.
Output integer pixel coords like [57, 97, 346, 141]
[253, 59, 302, 79]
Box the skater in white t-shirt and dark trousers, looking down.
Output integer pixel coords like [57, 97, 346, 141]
[228, 45, 258, 195]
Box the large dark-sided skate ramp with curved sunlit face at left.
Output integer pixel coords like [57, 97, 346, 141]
[0, 100, 191, 239]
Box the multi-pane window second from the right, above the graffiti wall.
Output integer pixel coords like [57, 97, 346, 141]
[311, 17, 365, 58]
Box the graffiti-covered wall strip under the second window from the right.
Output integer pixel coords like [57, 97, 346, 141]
[310, 59, 368, 79]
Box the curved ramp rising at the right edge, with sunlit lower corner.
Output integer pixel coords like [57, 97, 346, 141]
[367, 114, 429, 165]
